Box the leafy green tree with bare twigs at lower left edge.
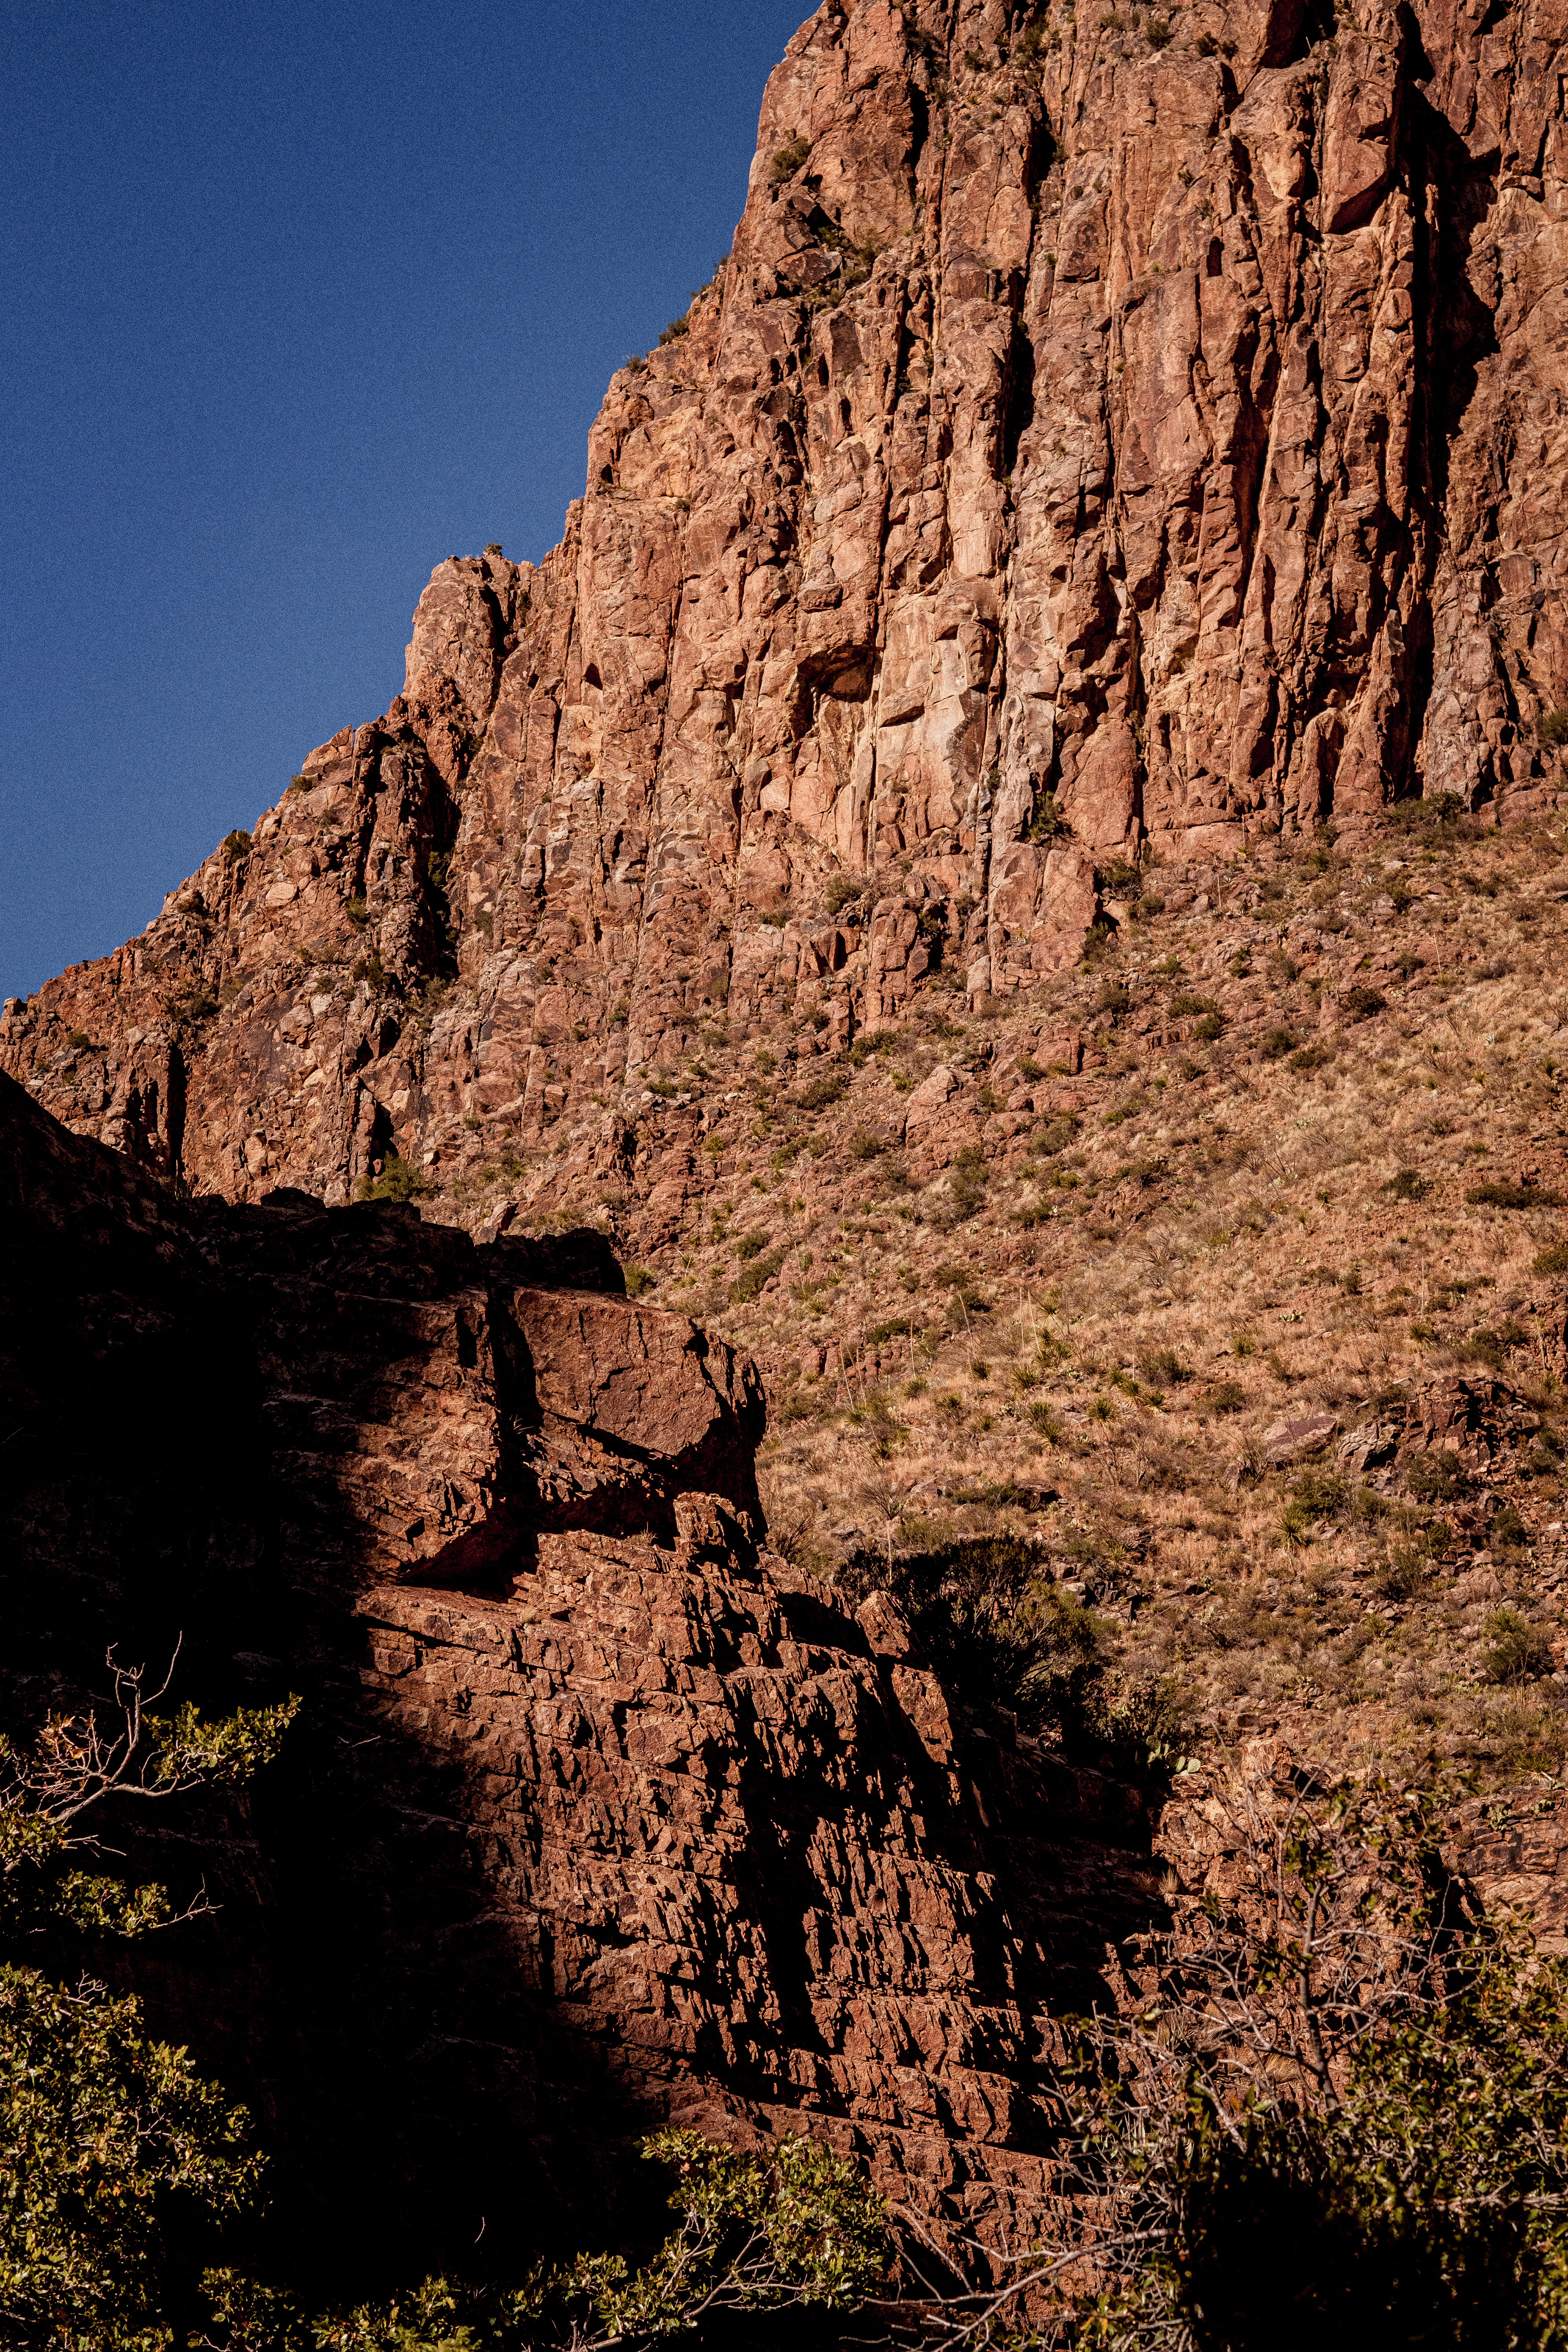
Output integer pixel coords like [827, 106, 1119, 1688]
[0, 1653, 299, 2352]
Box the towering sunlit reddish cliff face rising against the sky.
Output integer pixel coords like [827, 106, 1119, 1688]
[0, 0, 1568, 1223]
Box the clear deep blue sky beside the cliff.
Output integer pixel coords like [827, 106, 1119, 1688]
[0, 0, 809, 995]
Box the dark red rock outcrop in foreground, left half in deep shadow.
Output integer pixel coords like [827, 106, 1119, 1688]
[0, 1080, 1159, 2272]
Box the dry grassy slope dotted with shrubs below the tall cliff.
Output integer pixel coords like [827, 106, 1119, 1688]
[430, 802, 1568, 1783]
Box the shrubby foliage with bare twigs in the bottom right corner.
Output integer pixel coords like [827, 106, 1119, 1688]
[1070, 1783, 1568, 2352]
